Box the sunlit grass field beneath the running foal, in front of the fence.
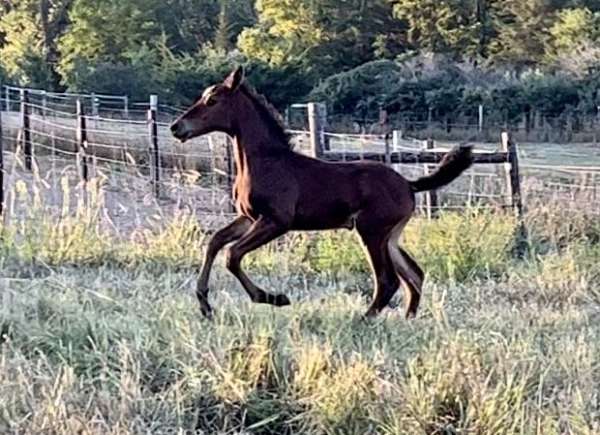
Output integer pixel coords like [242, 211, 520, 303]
[0, 175, 600, 434]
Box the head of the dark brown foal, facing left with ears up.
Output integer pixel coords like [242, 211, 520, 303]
[171, 67, 244, 142]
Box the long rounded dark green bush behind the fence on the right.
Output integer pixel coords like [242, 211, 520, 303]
[308, 56, 599, 124]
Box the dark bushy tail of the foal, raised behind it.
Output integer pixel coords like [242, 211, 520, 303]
[409, 146, 473, 192]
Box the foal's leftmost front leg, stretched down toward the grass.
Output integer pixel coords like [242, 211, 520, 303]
[196, 216, 251, 318]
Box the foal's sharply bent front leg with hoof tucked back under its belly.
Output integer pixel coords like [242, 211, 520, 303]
[227, 217, 290, 307]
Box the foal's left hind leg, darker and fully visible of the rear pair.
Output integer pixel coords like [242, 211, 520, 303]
[358, 227, 400, 317]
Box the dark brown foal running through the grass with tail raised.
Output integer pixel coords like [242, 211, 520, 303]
[171, 68, 472, 318]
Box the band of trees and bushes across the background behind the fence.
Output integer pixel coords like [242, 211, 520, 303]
[0, 0, 600, 120]
